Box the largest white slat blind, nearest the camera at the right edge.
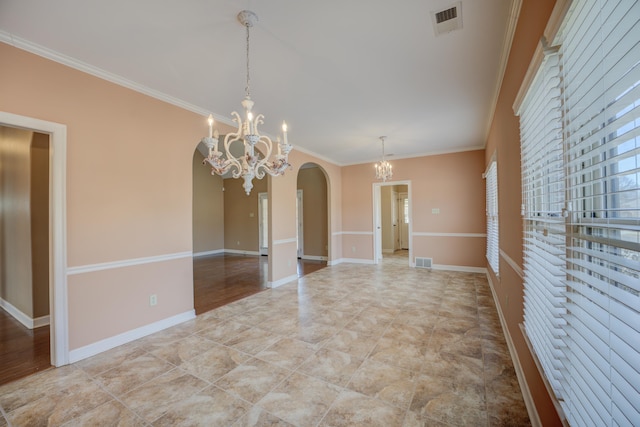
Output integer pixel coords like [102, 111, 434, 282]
[559, 0, 640, 426]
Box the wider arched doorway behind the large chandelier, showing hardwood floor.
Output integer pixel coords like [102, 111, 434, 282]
[192, 143, 269, 314]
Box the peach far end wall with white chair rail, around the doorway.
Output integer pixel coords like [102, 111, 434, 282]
[343, 150, 486, 268]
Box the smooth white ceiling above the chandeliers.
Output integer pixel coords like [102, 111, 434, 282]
[0, 0, 515, 165]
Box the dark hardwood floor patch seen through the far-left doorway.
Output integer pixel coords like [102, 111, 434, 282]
[0, 309, 51, 385]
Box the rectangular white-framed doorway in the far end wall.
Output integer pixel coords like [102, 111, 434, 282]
[373, 181, 413, 266]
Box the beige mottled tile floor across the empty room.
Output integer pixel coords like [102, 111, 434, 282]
[0, 257, 529, 427]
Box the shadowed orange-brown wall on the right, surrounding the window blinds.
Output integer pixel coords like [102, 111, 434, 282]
[485, 0, 561, 426]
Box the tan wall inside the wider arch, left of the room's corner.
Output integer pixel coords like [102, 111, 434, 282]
[193, 150, 224, 255]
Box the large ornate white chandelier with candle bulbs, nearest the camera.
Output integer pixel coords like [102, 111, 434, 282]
[202, 10, 292, 195]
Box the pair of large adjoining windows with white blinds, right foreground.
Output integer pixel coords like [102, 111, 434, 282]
[520, 0, 640, 426]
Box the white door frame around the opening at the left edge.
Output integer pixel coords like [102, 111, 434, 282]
[0, 111, 69, 366]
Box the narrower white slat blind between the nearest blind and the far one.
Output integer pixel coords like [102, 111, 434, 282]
[519, 53, 566, 398]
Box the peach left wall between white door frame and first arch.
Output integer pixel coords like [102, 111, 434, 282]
[0, 43, 220, 350]
